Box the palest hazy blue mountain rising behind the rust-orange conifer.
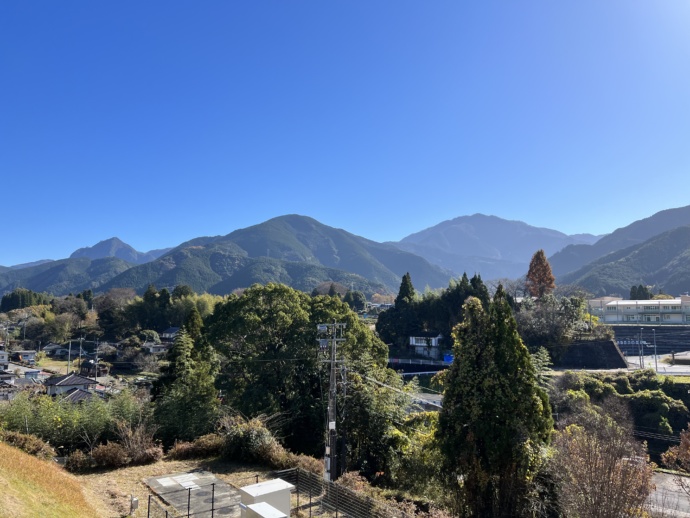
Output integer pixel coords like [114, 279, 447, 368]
[394, 214, 599, 279]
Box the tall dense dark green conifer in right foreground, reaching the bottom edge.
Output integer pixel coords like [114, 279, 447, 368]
[437, 286, 553, 517]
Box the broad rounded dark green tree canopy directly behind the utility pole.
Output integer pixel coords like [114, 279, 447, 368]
[206, 283, 387, 453]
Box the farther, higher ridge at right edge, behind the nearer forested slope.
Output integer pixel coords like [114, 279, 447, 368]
[547, 205, 690, 282]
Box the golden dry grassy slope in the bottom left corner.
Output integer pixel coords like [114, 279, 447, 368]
[0, 443, 100, 518]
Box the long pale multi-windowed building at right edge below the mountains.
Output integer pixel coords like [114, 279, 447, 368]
[588, 295, 690, 325]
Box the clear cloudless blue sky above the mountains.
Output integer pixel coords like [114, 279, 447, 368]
[0, 0, 690, 266]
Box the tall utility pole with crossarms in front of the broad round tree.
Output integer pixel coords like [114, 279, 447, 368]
[316, 319, 347, 482]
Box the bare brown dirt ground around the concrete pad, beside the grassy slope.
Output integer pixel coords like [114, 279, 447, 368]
[78, 459, 269, 518]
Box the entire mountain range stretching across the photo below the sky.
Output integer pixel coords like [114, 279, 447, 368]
[0, 206, 690, 295]
